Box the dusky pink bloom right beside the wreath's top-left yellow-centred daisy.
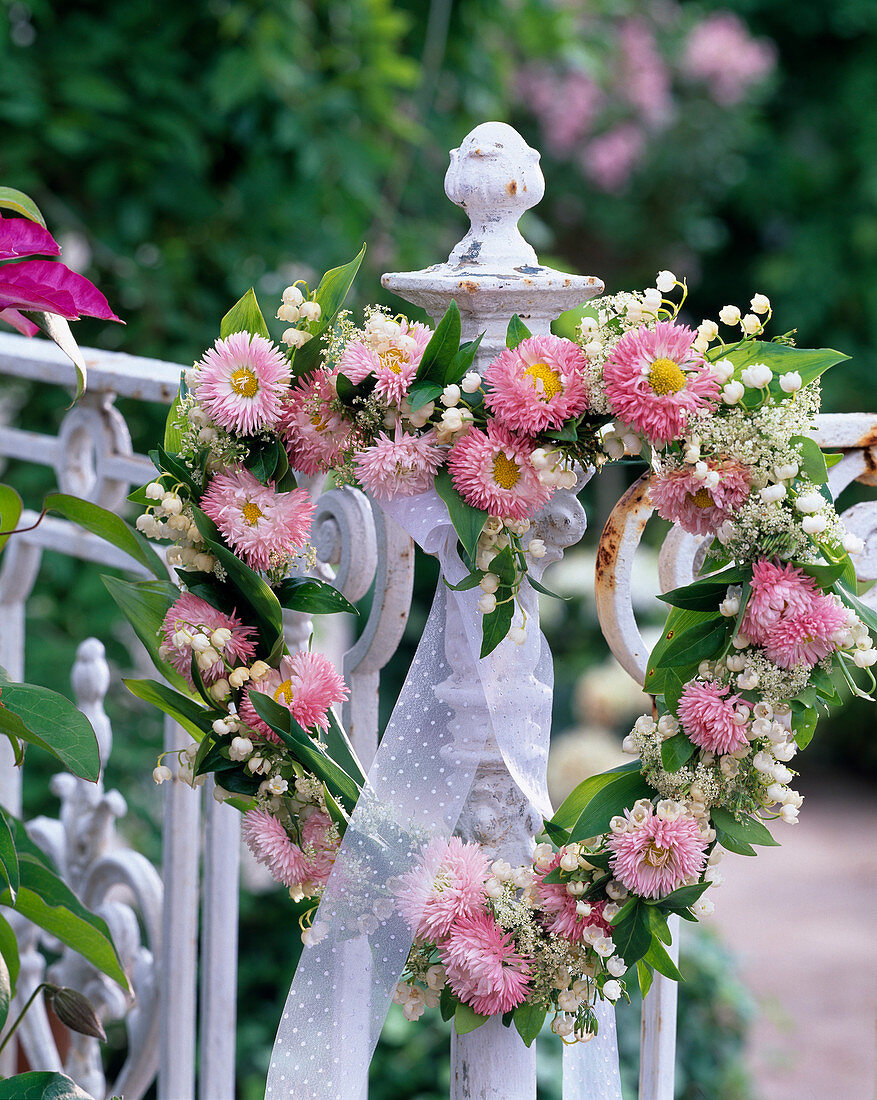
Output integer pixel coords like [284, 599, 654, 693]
[281, 371, 352, 477]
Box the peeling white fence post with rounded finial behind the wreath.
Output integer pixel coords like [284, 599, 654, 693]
[383, 116, 603, 1100]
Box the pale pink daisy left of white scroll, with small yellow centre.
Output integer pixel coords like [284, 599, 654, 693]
[201, 466, 317, 569]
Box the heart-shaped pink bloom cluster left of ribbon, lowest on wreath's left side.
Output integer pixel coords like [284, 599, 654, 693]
[241, 810, 339, 895]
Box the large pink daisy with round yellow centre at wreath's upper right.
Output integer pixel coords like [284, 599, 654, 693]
[603, 321, 720, 443]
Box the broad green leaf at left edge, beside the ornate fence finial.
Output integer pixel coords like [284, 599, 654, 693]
[0, 683, 100, 782]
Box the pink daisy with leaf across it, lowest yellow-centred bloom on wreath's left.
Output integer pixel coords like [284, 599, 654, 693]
[241, 651, 348, 740]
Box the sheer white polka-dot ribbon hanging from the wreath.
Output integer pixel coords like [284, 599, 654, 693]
[265, 491, 617, 1100]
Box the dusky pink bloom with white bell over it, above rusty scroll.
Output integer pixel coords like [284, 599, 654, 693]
[649, 459, 750, 535]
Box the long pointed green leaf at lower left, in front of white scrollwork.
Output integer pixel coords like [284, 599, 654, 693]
[8, 849, 129, 989]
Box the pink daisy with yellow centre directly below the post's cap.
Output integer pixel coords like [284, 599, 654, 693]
[484, 336, 588, 436]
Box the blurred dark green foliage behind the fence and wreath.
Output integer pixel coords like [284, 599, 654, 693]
[0, 0, 877, 1100]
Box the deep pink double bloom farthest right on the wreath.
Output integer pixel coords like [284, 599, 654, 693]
[741, 559, 846, 669]
